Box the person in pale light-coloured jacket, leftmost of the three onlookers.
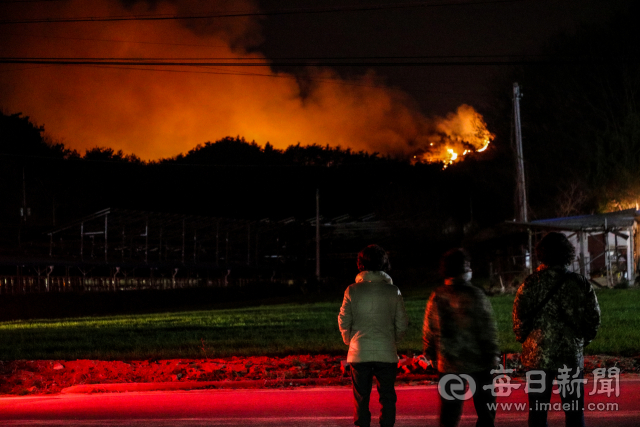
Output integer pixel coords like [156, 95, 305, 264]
[338, 245, 409, 427]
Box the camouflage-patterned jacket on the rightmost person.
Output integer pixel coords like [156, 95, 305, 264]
[513, 265, 600, 370]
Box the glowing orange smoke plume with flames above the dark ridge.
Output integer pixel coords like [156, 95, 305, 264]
[0, 0, 491, 164]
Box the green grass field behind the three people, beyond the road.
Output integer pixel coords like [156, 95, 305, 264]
[0, 289, 640, 360]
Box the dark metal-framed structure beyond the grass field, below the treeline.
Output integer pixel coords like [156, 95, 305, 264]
[47, 208, 292, 266]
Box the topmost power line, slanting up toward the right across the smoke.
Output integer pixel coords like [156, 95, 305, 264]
[0, 0, 529, 25]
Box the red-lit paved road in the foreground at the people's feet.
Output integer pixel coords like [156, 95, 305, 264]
[0, 380, 640, 427]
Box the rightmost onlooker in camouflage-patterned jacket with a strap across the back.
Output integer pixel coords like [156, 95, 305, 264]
[513, 232, 600, 427]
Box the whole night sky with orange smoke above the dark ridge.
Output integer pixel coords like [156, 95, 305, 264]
[0, 0, 630, 159]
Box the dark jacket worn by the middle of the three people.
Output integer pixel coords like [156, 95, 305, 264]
[423, 278, 500, 374]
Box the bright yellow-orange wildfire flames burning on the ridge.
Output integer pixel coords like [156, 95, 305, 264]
[413, 104, 495, 169]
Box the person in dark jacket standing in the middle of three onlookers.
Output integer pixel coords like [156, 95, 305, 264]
[423, 249, 500, 427]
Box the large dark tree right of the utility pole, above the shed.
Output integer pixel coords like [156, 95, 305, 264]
[507, 5, 640, 217]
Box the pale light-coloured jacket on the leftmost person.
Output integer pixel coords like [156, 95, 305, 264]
[338, 271, 409, 363]
